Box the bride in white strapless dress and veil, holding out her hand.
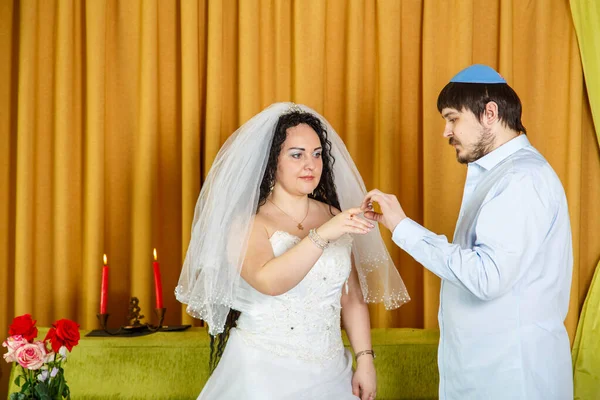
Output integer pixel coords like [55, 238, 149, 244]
[176, 103, 409, 400]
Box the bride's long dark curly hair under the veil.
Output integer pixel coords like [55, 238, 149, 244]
[209, 111, 340, 373]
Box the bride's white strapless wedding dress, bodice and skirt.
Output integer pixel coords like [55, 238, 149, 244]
[198, 231, 358, 400]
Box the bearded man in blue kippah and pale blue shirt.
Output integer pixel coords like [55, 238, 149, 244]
[363, 65, 573, 400]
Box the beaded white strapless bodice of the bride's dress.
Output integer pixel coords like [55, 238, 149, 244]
[233, 231, 352, 362]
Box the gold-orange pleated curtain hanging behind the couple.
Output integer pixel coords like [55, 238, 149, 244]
[0, 0, 600, 394]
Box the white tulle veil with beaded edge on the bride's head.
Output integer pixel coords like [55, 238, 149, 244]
[175, 103, 410, 335]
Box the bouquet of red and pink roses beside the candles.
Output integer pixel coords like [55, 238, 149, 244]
[2, 314, 80, 400]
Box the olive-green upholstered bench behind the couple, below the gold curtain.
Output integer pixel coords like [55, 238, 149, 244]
[9, 328, 439, 400]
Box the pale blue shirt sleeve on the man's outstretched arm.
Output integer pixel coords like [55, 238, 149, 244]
[392, 175, 556, 300]
